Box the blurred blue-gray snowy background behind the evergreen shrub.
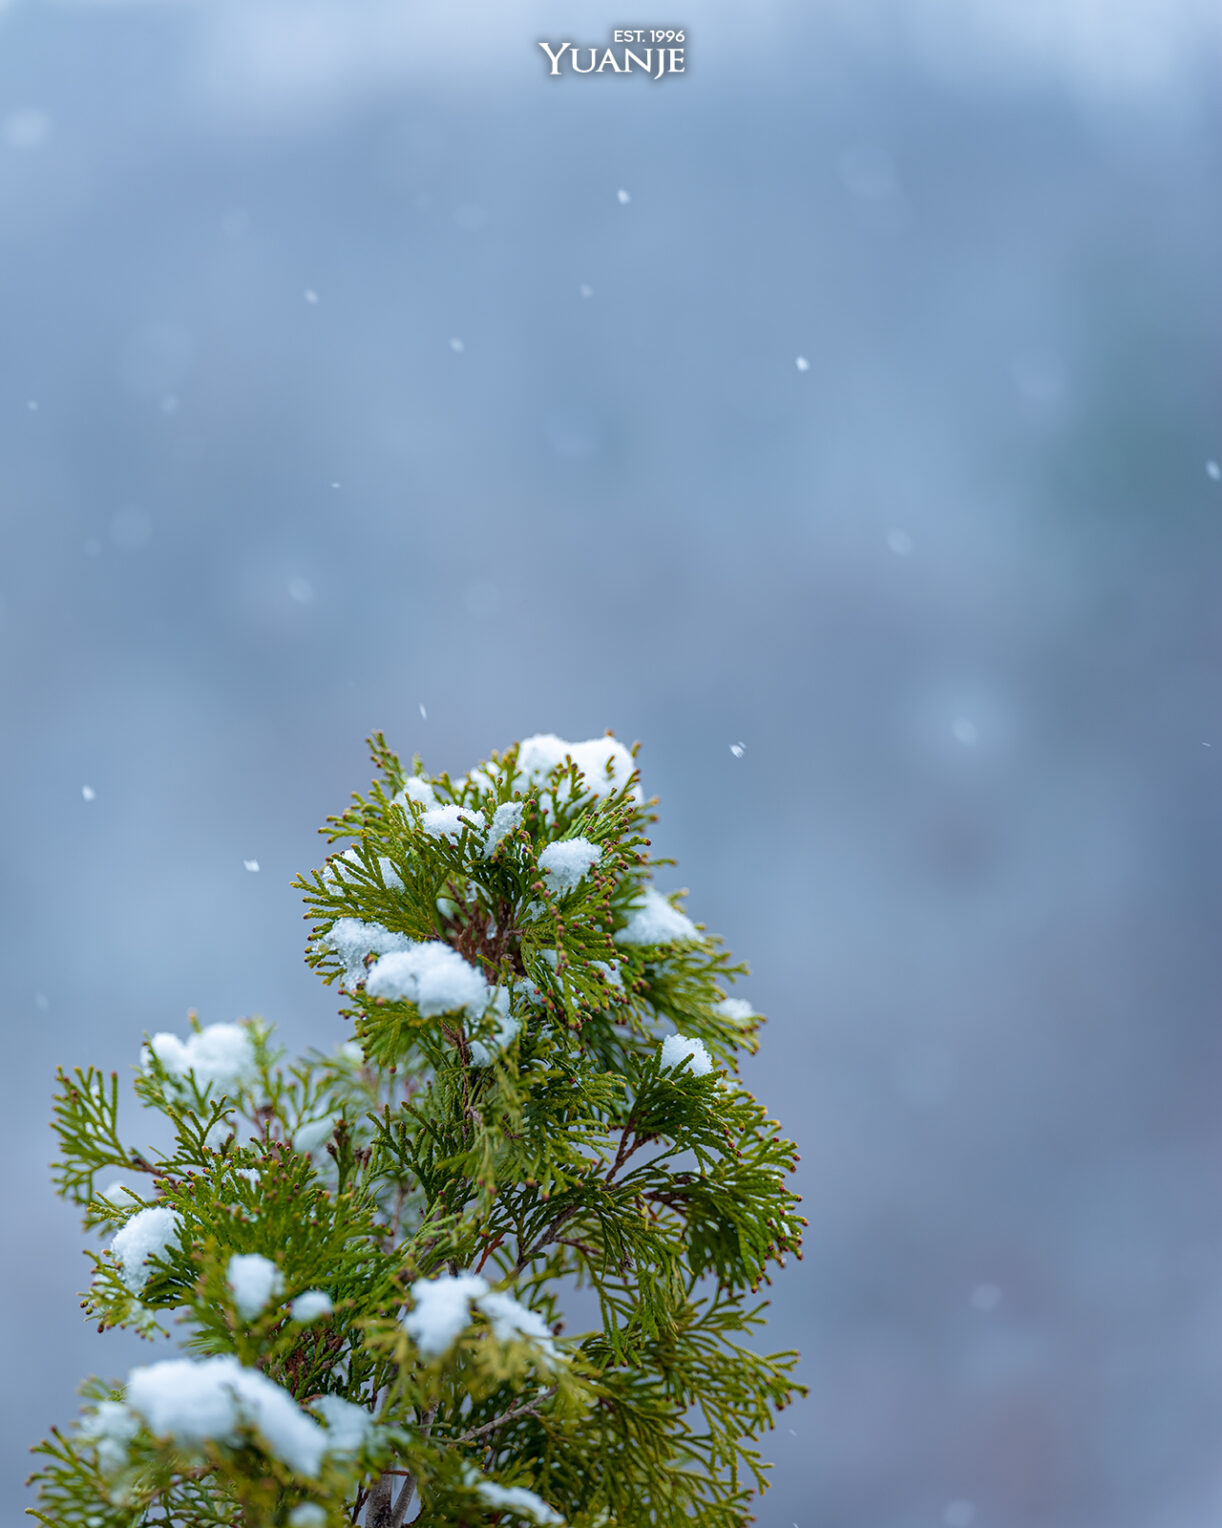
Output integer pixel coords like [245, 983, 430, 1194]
[0, 0, 1222, 1528]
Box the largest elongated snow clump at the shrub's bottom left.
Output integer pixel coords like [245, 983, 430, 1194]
[127, 1354, 328, 1478]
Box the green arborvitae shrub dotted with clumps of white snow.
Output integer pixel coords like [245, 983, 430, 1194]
[35, 736, 803, 1528]
